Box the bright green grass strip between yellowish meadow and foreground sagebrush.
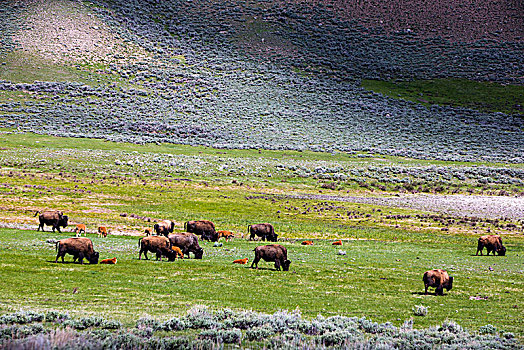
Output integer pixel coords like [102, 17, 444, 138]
[0, 229, 524, 335]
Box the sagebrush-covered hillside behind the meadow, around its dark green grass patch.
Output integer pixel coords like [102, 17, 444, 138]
[0, 0, 524, 163]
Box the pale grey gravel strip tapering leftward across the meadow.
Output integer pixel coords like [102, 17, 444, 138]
[290, 194, 524, 220]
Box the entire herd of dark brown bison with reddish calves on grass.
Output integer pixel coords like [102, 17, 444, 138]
[39, 210, 506, 295]
